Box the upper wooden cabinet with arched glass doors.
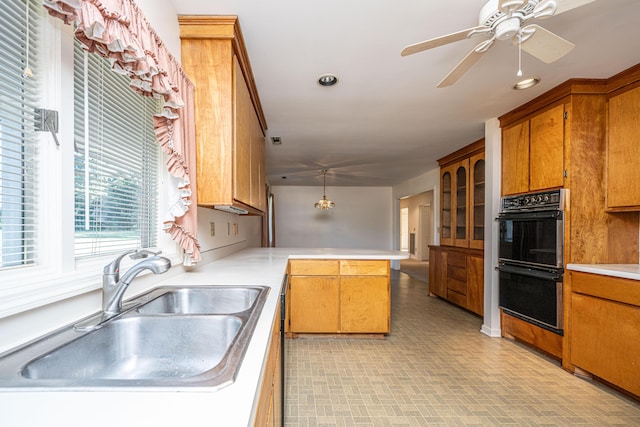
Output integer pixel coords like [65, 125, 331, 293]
[438, 139, 485, 249]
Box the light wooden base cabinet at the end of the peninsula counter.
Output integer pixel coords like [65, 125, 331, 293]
[287, 260, 391, 334]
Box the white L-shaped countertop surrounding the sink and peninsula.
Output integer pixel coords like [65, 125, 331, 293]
[0, 248, 408, 427]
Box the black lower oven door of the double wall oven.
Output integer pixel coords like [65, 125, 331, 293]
[498, 264, 564, 335]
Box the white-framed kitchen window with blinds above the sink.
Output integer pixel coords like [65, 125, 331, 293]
[0, 0, 175, 317]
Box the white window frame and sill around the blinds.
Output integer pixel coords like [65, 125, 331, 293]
[0, 11, 182, 318]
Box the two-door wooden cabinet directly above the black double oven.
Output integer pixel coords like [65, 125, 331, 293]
[501, 104, 565, 195]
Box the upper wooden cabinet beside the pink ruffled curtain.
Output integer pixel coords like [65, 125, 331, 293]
[178, 16, 267, 214]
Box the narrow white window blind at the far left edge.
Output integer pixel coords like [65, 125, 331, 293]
[0, 0, 42, 268]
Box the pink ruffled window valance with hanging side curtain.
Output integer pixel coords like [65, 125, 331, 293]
[43, 0, 200, 265]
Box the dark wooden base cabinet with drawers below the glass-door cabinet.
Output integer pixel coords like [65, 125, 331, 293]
[429, 246, 484, 316]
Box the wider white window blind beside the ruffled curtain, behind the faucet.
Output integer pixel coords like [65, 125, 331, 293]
[74, 42, 160, 258]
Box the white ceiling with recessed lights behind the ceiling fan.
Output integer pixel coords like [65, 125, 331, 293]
[172, 0, 640, 186]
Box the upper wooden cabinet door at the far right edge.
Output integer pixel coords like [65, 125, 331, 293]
[607, 87, 640, 208]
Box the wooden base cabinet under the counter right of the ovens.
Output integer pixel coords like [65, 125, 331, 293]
[571, 272, 640, 396]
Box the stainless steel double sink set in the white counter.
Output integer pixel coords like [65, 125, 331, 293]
[0, 286, 269, 389]
